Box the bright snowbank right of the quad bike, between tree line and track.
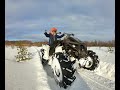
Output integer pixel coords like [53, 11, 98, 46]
[88, 47, 115, 81]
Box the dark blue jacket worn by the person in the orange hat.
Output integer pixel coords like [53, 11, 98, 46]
[44, 32, 64, 45]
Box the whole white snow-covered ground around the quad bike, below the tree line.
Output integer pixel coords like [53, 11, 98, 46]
[5, 46, 115, 90]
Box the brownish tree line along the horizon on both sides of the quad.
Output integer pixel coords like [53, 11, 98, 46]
[5, 40, 115, 47]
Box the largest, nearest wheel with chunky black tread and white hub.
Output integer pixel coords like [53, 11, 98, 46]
[52, 53, 76, 88]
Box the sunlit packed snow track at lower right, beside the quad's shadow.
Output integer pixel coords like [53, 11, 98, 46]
[79, 70, 115, 90]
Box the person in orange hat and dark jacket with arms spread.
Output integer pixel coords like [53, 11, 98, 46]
[44, 27, 64, 55]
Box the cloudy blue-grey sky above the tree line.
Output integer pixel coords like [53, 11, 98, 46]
[5, 0, 115, 41]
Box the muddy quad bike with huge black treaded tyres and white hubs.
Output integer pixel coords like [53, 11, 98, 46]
[40, 33, 99, 89]
